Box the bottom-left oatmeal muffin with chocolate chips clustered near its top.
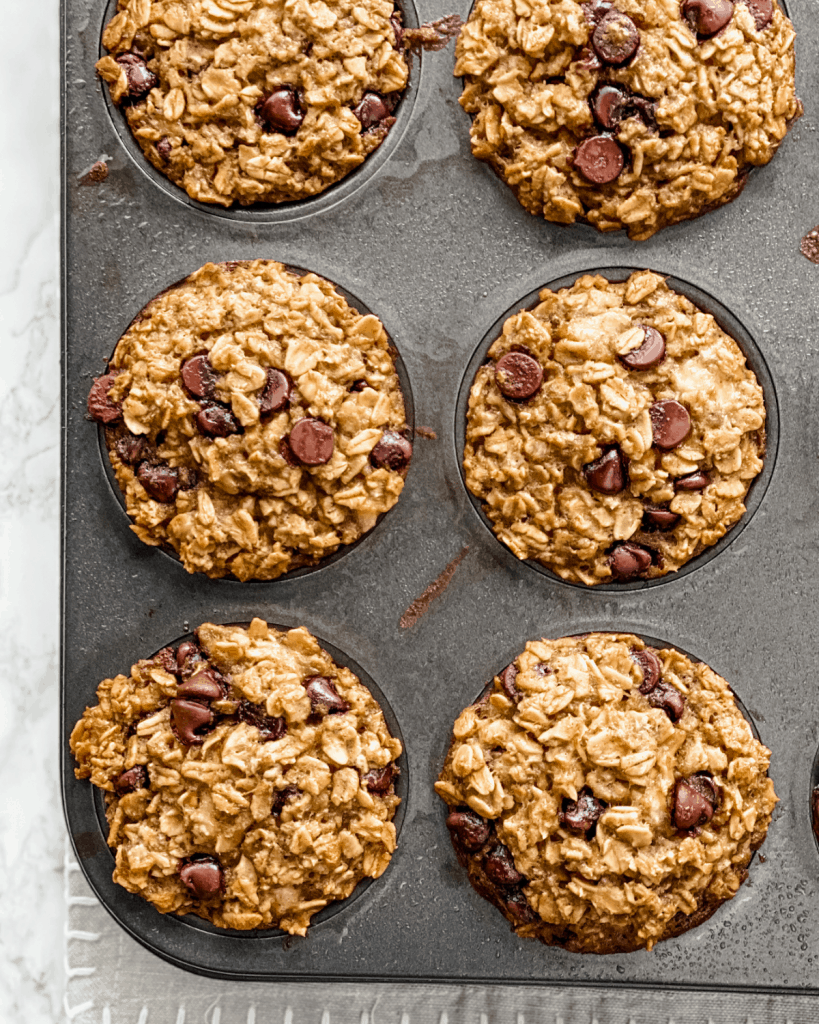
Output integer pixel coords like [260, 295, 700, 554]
[71, 618, 401, 935]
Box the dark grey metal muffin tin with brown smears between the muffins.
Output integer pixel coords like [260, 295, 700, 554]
[61, 0, 819, 1005]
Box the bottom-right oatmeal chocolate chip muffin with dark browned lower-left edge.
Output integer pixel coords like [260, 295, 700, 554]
[435, 633, 777, 953]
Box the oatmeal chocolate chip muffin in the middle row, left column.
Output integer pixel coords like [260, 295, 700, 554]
[88, 260, 413, 580]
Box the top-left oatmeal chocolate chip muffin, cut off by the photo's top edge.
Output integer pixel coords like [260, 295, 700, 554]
[96, 0, 408, 207]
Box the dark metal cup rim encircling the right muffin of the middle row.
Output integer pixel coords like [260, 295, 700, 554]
[451, 260, 780, 595]
